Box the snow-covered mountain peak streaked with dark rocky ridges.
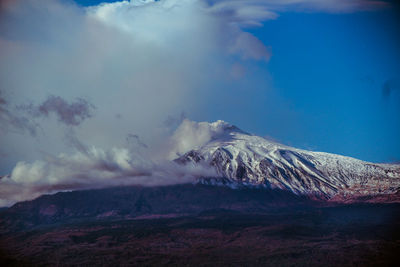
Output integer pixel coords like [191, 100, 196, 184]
[175, 121, 400, 199]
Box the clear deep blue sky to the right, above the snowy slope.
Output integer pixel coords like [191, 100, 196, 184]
[72, 0, 400, 162]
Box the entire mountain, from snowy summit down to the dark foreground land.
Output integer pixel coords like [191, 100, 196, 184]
[0, 121, 400, 266]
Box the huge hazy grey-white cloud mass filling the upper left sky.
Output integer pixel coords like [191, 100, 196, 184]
[0, 0, 276, 171]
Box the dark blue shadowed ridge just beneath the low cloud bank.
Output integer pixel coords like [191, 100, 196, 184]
[0, 184, 319, 231]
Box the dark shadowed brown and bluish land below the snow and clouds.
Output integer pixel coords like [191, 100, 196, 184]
[0, 185, 400, 266]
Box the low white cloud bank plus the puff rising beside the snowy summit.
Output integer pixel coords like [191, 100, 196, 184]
[0, 119, 244, 206]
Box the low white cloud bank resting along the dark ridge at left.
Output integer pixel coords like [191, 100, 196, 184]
[0, 121, 216, 206]
